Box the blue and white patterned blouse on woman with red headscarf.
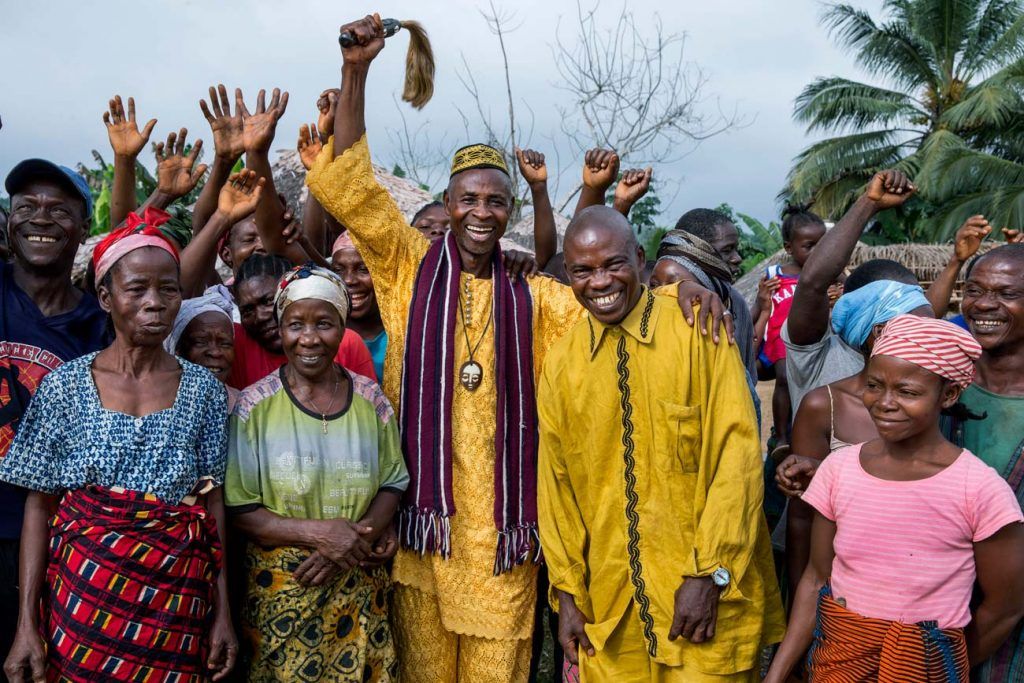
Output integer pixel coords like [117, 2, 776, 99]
[0, 353, 227, 504]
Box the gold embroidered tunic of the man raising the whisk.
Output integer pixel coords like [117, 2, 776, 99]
[306, 136, 583, 639]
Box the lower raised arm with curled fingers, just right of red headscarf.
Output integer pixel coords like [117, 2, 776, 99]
[181, 169, 265, 297]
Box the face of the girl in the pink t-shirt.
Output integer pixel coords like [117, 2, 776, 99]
[862, 355, 961, 442]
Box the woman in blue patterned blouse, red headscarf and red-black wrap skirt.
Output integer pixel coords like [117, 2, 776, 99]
[0, 178, 258, 683]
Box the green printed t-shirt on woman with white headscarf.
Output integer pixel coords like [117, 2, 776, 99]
[224, 368, 409, 520]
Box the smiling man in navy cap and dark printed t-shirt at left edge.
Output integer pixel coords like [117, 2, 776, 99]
[0, 159, 106, 657]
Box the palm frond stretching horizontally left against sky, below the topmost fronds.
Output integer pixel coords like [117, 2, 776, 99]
[794, 77, 928, 131]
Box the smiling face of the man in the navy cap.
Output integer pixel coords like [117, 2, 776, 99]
[7, 180, 88, 274]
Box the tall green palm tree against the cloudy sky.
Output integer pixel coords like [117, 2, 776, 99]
[781, 0, 1024, 241]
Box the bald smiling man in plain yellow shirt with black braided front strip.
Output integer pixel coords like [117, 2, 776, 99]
[538, 207, 783, 683]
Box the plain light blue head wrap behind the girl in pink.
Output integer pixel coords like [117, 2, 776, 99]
[831, 280, 930, 348]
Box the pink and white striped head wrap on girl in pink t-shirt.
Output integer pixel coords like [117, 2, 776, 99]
[871, 315, 981, 388]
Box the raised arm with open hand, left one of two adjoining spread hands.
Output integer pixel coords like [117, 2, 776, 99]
[193, 83, 245, 234]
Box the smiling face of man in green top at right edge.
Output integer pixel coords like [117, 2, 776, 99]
[961, 254, 1024, 353]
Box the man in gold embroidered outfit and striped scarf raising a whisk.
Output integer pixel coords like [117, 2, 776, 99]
[307, 13, 583, 683]
